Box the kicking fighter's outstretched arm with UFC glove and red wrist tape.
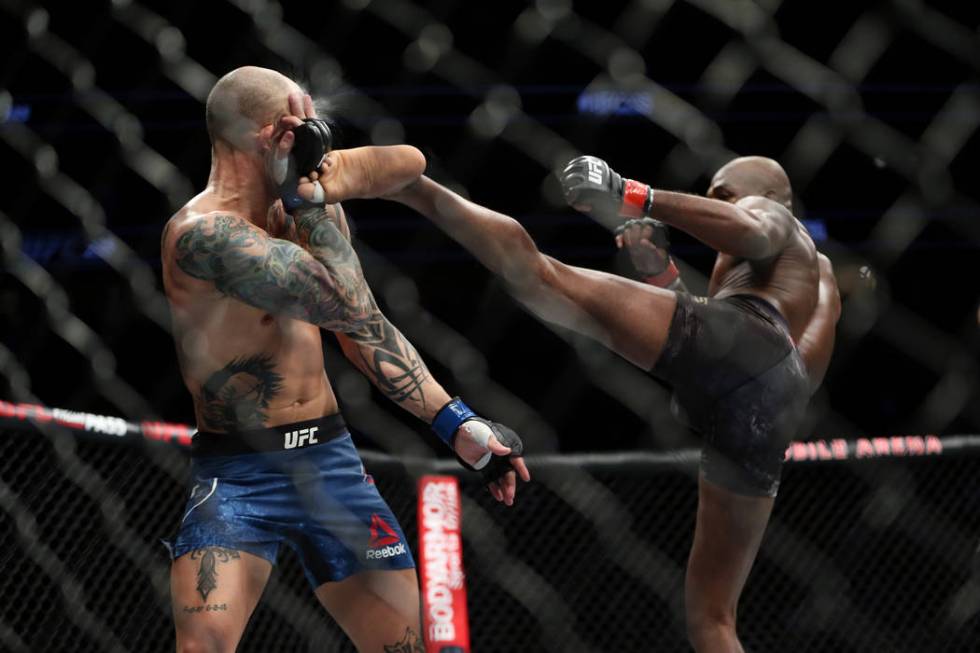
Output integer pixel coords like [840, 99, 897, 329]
[561, 156, 795, 260]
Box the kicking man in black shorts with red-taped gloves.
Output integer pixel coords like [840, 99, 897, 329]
[392, 157, 840, 652]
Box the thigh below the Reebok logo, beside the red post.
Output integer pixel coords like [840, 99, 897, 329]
[316, 569, 425, 653]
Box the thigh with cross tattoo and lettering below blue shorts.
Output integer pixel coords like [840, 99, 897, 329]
[170, 547, 272, 651]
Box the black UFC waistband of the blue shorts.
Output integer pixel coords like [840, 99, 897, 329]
[191, 413, 347, 457]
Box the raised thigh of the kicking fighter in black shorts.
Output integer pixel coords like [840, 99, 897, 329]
[543, 257, 677, 370]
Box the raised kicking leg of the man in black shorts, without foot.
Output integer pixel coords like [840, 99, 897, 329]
[391, 177, 677, 370]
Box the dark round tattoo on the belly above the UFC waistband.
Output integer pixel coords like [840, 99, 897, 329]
[198, 354, 283, 431]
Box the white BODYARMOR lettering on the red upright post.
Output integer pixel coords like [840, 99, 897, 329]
[422, 482, 464, 641]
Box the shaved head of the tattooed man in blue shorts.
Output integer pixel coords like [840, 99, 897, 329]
[206, 66, 302, 150]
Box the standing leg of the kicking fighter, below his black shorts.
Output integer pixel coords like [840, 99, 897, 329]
[684, 477, 774, 653]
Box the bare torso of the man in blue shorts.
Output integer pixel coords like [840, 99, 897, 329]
[161, 191, 347, 432]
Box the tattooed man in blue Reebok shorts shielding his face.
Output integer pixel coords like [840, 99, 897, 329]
[162, 67, 528, 653]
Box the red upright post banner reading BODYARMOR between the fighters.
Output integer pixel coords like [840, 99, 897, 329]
[418, 476, 470, 653]
